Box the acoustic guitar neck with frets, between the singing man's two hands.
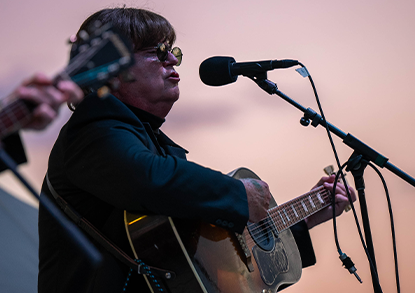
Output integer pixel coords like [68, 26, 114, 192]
[268, 186, 331, 232]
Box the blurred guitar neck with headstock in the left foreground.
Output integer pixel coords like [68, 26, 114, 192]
[0, 24, 134, 138]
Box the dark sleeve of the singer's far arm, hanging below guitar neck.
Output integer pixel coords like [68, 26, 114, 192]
[291, 221, 316, 268]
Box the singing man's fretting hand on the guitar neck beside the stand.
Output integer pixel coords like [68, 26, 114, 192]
[305, 175, 356, 229]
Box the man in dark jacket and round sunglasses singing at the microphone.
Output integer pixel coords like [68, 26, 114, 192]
[38, 8, 354, 292]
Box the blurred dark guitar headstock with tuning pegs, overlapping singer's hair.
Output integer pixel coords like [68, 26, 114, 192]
[60, 24, 134, 91]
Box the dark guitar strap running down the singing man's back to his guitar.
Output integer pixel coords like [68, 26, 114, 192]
[46, 173, 175, 280]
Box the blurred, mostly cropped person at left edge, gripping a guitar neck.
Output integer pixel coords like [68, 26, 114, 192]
[0, 73, 84, 171]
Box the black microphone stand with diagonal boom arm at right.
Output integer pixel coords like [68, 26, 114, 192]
[247, 72, 415, 293]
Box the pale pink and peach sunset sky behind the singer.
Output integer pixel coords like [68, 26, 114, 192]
[0, 0, 415, 293]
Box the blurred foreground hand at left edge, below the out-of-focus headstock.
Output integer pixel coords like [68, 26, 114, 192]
[14, 73, 84, 130]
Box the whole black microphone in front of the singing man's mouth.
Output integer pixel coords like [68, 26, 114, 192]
[199, 56, 299, 86]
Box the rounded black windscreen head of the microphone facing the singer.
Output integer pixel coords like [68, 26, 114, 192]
[199, 56, 238, 86]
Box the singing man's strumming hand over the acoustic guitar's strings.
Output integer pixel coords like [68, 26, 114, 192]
[241, 179, 271, 223]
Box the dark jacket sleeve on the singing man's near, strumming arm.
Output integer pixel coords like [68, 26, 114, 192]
[64, 120, 249, 233]
